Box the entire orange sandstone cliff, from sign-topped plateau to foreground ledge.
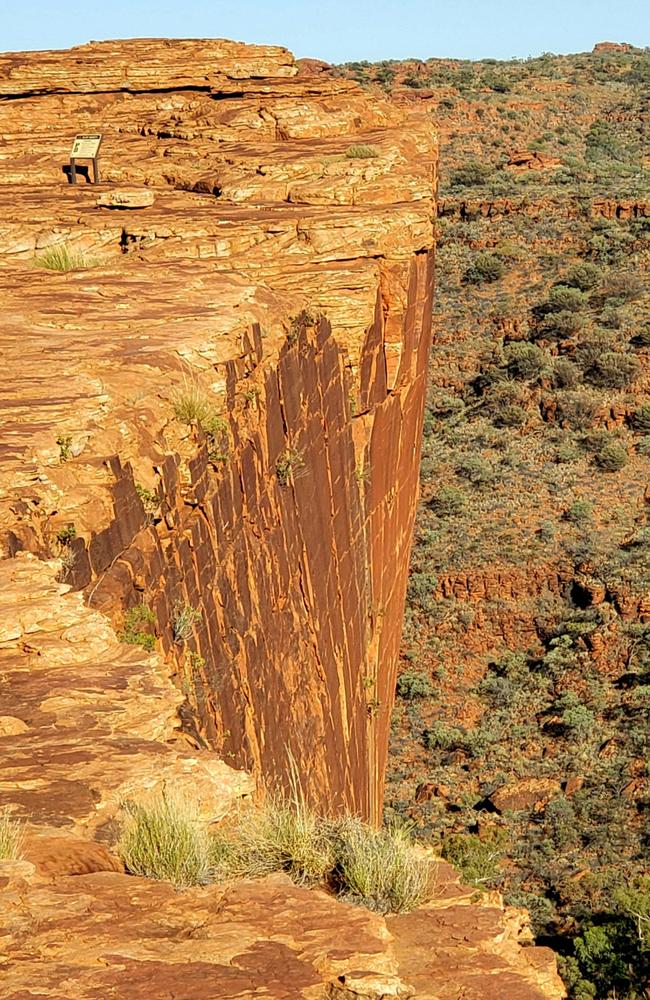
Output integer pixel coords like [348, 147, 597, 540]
[0, 41, 561, 1000]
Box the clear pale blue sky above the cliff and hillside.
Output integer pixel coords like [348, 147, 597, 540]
[0, 0, 650, 62]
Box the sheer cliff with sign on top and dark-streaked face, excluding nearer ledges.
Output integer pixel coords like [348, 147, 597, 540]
[0, 40, 436, 821]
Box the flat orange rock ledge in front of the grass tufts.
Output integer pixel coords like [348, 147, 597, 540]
[0, 861, 564, 1000]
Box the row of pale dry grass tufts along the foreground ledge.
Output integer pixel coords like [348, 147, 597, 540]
[119, 789, 435, 913]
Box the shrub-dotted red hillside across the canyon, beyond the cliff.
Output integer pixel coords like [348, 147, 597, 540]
[346, 43, 650, 1000]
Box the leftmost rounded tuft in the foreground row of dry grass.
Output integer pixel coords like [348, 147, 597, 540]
[118, 795, 212, 888]
